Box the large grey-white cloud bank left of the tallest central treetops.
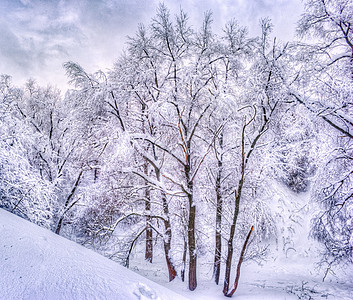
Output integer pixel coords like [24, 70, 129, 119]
[0, 0, 159, 86]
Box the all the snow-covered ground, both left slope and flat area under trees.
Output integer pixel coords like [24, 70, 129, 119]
[0, 185, 353, 300]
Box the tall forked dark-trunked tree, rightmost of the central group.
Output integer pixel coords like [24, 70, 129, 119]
[223, 19, 289, 296]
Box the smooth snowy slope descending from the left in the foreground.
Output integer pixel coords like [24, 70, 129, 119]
[0, 209, 185, 300]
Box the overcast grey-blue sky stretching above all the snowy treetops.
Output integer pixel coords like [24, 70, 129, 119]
[0, 0, 303, 90]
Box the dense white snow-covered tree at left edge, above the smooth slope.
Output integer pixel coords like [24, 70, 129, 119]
[0, 75, 56, 228]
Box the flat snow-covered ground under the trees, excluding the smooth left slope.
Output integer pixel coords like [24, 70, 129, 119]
[131, 183, 353, 300]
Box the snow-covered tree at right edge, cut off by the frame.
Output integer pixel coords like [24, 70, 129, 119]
[293, 0, 353, 267]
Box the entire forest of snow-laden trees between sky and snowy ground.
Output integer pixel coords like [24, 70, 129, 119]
[0, 0, 353, 297]
